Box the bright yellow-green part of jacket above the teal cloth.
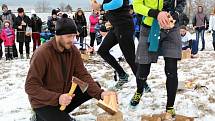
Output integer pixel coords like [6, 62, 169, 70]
[133, 0, 163, 26]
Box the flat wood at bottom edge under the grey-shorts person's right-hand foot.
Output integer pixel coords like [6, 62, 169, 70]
[141, 113, 194, 121]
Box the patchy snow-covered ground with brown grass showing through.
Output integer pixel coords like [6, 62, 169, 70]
[0, 29, 215, 121]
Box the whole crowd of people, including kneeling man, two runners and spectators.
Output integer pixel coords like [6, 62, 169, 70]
[1, 0, 215, 121]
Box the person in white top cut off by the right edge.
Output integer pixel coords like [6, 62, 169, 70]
[209, 7, 215, 51]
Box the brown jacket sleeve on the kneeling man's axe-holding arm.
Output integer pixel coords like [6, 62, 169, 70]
[25, 49, 61, 106]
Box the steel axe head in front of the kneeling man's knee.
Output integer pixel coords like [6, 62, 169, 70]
[72, 76, 89, 93]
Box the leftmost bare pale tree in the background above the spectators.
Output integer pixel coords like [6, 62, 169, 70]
[35, 0, 50, 12]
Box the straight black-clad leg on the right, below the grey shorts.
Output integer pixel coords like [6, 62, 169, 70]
[164, 57, 178, 115]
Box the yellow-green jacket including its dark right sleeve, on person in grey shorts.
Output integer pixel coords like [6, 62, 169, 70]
[133, 0, 186, 26]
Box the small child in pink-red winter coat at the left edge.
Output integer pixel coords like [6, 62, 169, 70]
[1, 21, 15, 60]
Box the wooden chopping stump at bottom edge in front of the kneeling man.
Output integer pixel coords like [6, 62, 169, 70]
[96, 111, 123, 121]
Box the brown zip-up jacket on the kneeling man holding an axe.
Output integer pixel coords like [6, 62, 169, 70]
[25, 39, 103, 108]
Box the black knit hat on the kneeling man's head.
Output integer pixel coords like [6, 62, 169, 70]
[55, 15, 77, 35]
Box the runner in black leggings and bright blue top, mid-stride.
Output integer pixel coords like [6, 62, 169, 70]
[92, 0, 150, 91]
